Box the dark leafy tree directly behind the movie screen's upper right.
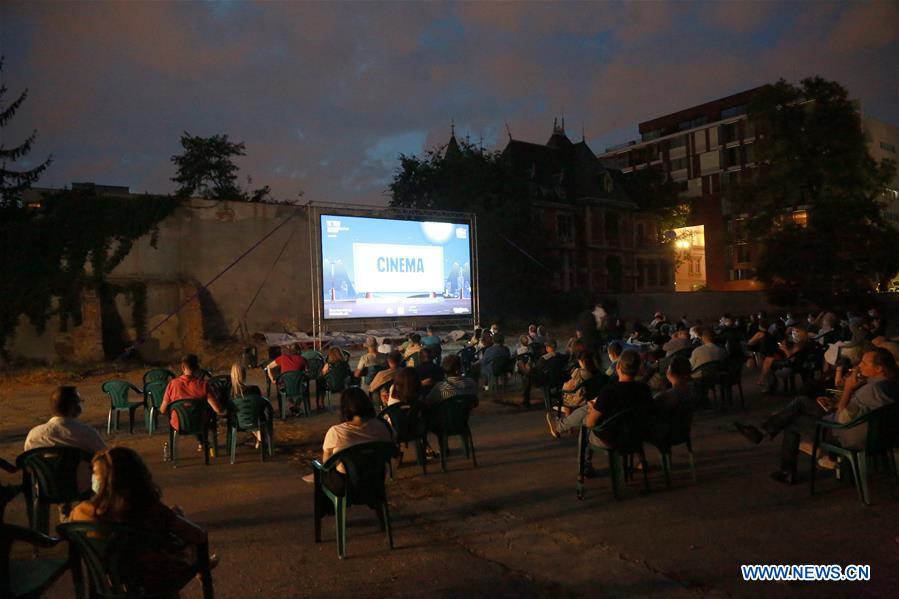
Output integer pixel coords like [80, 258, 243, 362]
[388, 141, 556, 315]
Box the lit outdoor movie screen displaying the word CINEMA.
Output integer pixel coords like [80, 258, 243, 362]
[321, 215, 472, 319]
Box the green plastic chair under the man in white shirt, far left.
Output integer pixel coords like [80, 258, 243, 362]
[16, 446, 94, 534]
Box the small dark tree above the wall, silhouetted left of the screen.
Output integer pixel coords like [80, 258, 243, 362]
[172, 131, 246, 200]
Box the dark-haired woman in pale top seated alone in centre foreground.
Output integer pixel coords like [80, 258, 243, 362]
[303, 390, 394, 492]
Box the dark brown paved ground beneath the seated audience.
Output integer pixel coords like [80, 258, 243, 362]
[0, 366, 899, 597]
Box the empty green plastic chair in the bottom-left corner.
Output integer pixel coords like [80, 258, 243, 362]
[0, 524, 69, 599]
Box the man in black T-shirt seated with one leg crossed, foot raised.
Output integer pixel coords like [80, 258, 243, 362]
[546, 350, 652, 444]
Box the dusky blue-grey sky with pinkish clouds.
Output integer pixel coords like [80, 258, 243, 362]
[0, 0, 899, 203]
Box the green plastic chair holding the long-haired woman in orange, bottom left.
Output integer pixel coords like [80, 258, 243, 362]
[56, 522, 214, 599]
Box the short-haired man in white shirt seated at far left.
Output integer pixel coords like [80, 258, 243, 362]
[24, 387, 106, 500]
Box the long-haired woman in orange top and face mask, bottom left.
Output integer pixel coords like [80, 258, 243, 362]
[71, 447, 216, 592]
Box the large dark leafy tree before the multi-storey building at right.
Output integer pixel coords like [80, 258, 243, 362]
[727, 77, 899, 304]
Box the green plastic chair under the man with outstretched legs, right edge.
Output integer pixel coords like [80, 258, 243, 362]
[809, 403, 899, 505]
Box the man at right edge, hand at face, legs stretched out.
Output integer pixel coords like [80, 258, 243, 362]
[734, 348, 899, 484]
